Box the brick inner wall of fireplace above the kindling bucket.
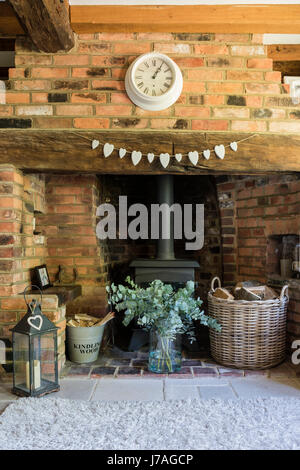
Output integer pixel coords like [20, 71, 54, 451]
[38, 175, 109, 317]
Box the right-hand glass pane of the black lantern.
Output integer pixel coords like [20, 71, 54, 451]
[35, 332, 56, 387]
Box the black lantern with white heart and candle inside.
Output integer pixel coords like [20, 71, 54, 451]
[11, 286, 59, 397]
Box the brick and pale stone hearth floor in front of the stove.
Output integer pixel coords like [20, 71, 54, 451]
[0, 352, 300, 412]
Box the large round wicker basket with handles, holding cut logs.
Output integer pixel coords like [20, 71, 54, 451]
[208, 277, 289, 369]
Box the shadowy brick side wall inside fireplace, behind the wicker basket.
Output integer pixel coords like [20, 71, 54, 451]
[217, 174, 300, 342]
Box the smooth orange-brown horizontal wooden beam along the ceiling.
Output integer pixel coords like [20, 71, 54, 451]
[70, 2, 300, 34]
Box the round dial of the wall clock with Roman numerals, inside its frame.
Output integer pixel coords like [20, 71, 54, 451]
[133, 55, 174, 97]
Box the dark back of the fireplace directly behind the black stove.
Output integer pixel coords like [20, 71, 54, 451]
[99, 175, 222, 349]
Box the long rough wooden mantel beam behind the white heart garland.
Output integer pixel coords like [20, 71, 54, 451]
[0, 130, 300, 175]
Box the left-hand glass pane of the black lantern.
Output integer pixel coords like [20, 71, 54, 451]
[14, 333, 30, 392]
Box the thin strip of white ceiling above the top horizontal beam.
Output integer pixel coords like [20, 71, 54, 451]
[69, 0, 300, 5]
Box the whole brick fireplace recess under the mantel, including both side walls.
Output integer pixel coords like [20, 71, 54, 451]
[0, 166, 300, 365]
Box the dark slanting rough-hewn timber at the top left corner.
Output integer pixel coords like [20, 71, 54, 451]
[9, 0, 75, 52]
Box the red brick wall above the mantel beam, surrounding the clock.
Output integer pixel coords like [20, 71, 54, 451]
[0, 33, 300, 133]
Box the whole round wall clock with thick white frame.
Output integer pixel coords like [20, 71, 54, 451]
[125, 52, 183, 111]
